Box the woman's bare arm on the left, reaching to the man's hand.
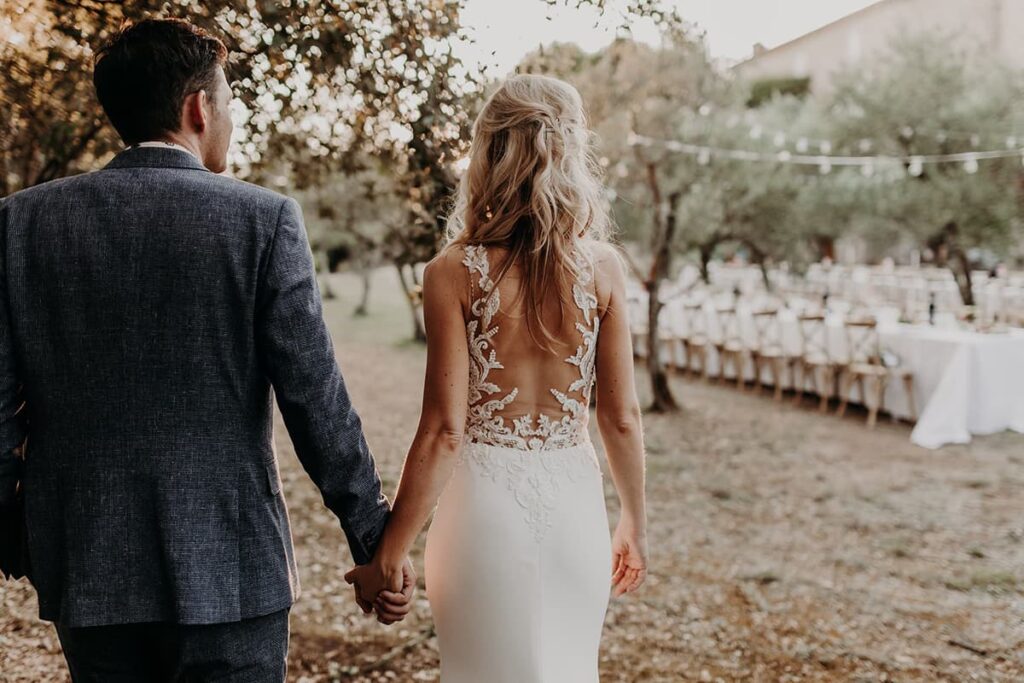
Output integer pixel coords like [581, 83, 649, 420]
[348, 251, 469, 595]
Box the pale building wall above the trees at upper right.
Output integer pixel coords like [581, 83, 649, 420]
[735, 0, 1024, 94]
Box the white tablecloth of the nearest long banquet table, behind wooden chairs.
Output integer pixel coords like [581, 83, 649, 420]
[647, 301, 1024, 449]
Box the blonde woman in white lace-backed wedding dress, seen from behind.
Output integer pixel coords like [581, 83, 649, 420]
[346, 76, 647, 683]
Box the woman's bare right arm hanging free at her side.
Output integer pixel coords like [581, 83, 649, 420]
[597, 244, 647, 595]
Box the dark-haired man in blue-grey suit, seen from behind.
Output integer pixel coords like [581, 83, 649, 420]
[0, 20, 415, 682]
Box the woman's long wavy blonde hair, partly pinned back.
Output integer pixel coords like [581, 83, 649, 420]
[447, 75, 610, 351]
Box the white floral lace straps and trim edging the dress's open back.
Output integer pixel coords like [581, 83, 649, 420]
[463, 246, 600, 451]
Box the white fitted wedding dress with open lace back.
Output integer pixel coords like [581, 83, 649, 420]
[424, 247, 611, 683]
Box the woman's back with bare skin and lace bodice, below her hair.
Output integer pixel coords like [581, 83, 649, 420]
[462, 246, 602, 451]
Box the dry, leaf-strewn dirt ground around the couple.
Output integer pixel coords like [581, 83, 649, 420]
[0, 271, 1024, 683]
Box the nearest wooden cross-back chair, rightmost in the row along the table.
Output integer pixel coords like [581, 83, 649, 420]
[837, 321, 918, 427]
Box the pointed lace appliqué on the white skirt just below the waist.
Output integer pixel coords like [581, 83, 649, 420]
[463, 443, 602, 543]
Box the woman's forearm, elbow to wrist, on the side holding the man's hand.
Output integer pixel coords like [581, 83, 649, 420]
[375, 429, 462, 567]
